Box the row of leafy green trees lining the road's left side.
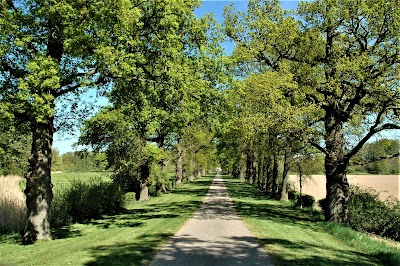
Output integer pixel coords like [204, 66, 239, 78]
[0, 0, 222, 244]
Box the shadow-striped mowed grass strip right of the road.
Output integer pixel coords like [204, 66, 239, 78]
[224, 176, 400, 266]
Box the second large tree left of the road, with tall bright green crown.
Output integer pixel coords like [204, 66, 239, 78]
[79, 1, 225, 195]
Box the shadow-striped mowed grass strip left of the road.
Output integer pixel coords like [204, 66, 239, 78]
[0, 176, 214, 265]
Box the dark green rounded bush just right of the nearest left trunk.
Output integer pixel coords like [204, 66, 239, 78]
[51, 178, 123, 227]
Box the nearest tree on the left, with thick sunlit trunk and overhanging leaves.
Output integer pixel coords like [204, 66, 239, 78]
[0, 0, 172, 244]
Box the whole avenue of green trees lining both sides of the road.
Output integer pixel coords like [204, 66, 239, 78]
[0, 0, 400, 244]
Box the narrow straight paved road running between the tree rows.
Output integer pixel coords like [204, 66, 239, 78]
[150, 175, 273, 266]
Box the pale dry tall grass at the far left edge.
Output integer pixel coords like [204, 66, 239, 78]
[0, 176, 26, 232]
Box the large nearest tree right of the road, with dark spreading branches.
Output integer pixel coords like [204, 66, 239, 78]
[226, 0, 400, 223]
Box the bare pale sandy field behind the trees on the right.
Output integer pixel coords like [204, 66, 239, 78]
[289, 175, 400, 200]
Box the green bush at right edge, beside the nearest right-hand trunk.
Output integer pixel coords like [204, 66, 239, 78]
[348, 186, 400, 241]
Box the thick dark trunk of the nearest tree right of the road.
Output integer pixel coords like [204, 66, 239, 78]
[325, 114, 350, 224]
